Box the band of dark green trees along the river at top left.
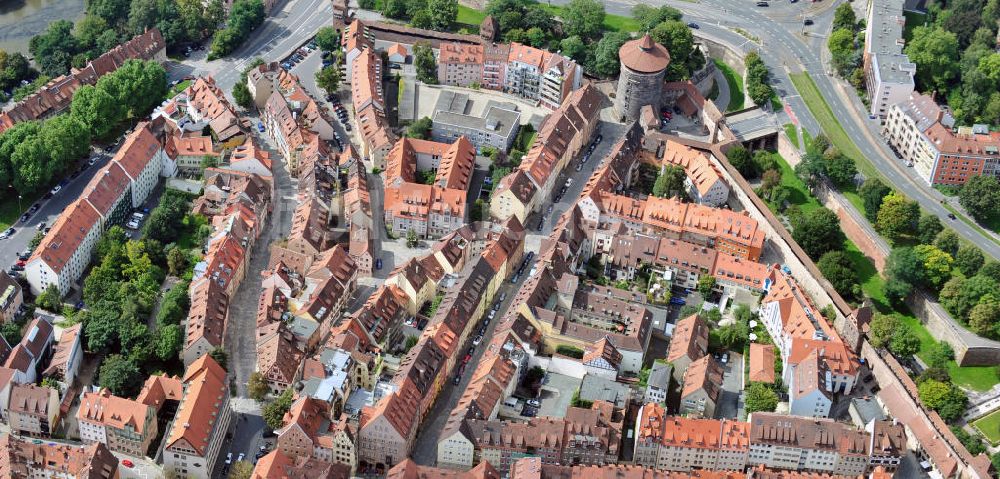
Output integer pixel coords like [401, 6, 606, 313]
[28, 0, 225, 76]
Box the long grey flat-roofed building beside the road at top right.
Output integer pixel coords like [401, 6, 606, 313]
[863, 0, 917, 118]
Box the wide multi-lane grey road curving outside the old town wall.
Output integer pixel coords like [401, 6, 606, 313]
[552, 0, 1000, 259]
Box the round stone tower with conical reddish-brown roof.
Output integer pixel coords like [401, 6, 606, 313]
[615, 33, 670, 121]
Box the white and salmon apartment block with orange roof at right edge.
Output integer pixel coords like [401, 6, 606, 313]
[882, 93, 1000, 186]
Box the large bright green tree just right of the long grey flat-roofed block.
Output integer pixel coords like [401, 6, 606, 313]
[903, 26, 959, 91]
